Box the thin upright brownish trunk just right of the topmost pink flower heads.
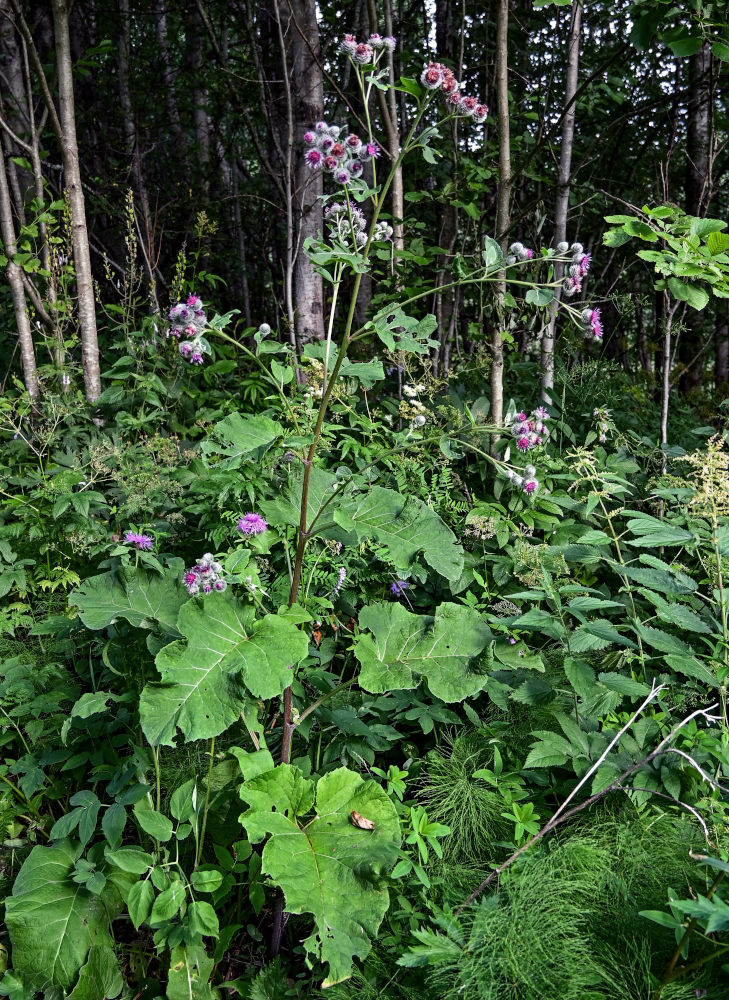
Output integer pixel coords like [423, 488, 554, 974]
[491, 0, 511, 438]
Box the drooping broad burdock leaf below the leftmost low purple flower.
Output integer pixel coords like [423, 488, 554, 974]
[69, 559, 189, 636]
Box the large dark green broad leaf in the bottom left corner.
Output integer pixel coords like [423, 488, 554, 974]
[5, 840, 112, 992]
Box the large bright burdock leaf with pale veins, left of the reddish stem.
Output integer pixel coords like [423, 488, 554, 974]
[139, 590, 308, 746]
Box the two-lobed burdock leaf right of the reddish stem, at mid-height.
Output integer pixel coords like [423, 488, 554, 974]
[355, 604, 493, 702]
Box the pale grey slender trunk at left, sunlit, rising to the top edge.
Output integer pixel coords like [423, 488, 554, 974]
[53, 0, 101, 403]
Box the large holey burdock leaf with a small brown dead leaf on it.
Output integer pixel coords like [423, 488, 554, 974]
[241, 764, 400, 986]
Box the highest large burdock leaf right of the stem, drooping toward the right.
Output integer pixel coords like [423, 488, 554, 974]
[334, 486, 463, 582]
